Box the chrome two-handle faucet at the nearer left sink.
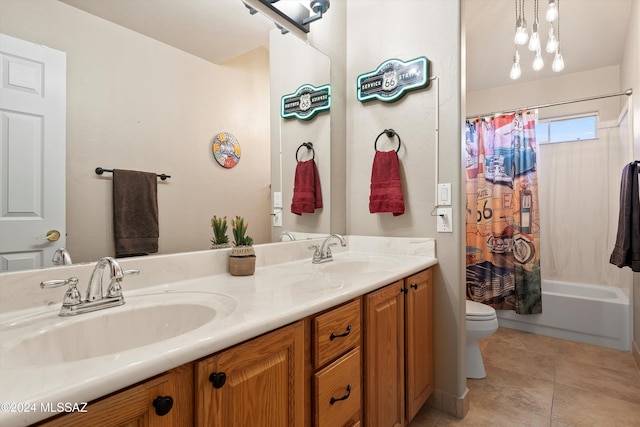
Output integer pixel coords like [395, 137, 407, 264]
[40, 257, 140, 316]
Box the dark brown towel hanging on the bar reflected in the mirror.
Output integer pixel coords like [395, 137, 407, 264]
[113, 169, 160, 257]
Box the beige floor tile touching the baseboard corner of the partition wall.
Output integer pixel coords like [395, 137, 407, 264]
[467, 365, 553, 417]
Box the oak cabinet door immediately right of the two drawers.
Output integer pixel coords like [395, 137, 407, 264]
[364, 280, 404, 427]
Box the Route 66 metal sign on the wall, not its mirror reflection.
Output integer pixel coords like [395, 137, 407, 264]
[358, 56, 429, 102]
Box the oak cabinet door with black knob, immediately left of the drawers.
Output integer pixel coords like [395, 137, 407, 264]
[195, 322, 304, 427]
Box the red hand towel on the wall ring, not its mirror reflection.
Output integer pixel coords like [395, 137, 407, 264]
[369, 151, 404, 216]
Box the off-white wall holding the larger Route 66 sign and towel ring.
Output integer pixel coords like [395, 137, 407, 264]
[344, 0, 466, 414]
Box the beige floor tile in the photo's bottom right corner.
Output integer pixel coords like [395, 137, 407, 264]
[552, 384, 640, 427]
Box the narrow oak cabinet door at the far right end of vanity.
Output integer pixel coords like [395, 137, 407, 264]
[405, 270, 433, 424]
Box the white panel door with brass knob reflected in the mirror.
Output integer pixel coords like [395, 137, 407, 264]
[0, 34, 67, 271]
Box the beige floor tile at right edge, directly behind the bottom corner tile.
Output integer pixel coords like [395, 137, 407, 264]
[556, 360, 640, 406]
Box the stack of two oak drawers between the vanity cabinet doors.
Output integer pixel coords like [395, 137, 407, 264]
[311, 298, 362, 427]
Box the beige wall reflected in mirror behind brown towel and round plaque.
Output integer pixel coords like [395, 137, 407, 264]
[0, 0, 271, 261]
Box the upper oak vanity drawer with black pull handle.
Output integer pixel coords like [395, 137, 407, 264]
[313, 299, 360, 369]
